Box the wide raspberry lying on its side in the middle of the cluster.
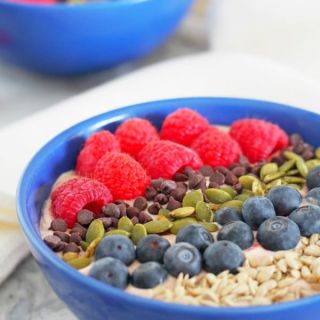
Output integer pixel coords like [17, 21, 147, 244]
[137, 140, 202, 179]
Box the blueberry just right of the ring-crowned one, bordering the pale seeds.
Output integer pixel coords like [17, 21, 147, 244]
[203, 240, 244, 274]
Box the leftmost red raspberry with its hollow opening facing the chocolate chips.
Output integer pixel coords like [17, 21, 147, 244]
[51, 177, 112, 228]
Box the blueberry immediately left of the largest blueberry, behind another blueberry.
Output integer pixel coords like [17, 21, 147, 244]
[218, 221, 254, 250]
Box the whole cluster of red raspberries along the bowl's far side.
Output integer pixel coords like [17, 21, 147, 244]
[51, 108, 288, 227]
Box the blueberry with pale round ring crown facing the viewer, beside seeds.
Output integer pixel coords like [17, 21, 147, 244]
[163, 242, 202, 277]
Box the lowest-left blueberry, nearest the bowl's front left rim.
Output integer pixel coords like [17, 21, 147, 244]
[89, 257, 129, 289]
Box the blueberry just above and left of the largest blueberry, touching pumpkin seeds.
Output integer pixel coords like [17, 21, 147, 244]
[242, 197, 276, 230]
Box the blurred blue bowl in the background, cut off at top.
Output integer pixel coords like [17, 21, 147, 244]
[0, 0, 193, 75]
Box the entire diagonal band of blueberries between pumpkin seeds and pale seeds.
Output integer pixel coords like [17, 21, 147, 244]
[89, 167, 320, 289]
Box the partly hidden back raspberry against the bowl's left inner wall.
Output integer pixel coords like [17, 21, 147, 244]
[76, 130, 120, 178]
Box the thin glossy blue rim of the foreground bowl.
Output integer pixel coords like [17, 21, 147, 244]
[16, 97, 320, 316]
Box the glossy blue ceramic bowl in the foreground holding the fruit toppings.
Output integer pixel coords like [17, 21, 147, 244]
[17, 98, 320, 320]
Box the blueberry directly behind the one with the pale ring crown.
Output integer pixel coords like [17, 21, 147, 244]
[176, 224, 214, 252]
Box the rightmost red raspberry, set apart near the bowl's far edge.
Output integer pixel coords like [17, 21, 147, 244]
[230, 119, 286, 163]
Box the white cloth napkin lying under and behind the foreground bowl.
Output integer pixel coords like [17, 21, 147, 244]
[0, 53, 320, 282]
